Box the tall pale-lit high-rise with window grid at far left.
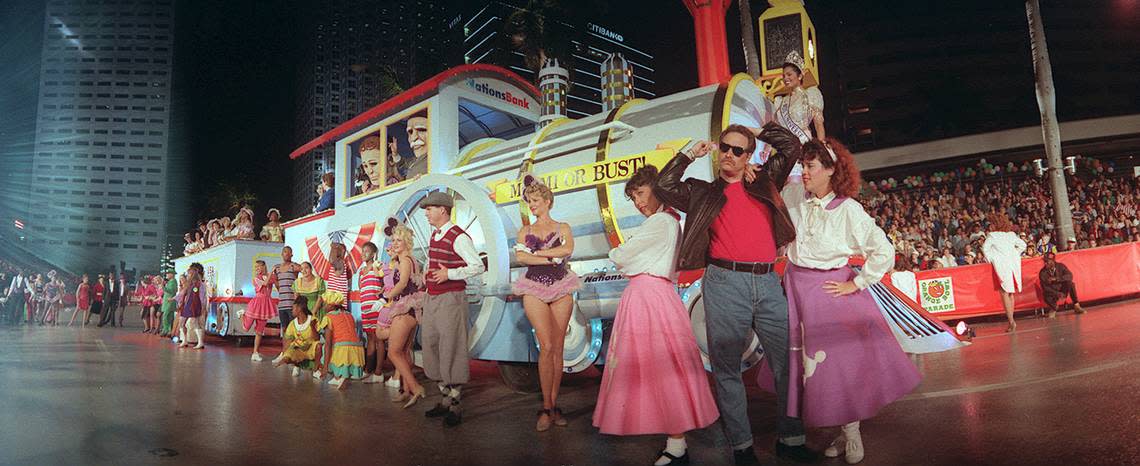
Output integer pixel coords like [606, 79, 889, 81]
[25, 0, 173, 272]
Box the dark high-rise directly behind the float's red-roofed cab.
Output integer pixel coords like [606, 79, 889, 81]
[287, 0, 462, 218]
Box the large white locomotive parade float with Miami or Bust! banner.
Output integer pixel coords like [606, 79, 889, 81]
[273, 1, 953, 386]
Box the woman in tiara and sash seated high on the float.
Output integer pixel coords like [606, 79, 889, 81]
[775, 51, 828, 142]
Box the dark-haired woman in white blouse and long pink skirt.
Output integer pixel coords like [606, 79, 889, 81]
[594, 165, 719, 466]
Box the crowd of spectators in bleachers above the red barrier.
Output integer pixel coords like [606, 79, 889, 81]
[862, 160, 1140, 270]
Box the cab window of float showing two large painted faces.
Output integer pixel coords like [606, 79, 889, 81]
[347, 106, 431, 198]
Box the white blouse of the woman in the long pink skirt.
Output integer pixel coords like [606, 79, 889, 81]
[610, 207, 681, 281]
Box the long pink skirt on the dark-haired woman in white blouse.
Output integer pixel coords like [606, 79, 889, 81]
[594, 275, 720, 435]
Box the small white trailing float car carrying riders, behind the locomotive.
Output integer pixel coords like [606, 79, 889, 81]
[174, 239, 282, 338]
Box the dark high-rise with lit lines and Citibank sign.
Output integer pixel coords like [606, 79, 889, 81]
[462, 0, 657, 118]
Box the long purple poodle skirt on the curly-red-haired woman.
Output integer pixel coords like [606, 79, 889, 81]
[758, 263, 922, 427]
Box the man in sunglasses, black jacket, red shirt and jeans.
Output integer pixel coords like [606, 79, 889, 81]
[653, 123, 819, 465]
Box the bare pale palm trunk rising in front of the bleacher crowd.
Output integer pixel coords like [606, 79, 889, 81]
[1025, 0, 1076, 248]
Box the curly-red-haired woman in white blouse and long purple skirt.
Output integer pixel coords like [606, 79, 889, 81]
[760, 139, 922, 464]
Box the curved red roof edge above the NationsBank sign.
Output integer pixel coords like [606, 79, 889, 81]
[288, 63, 542, 158]
